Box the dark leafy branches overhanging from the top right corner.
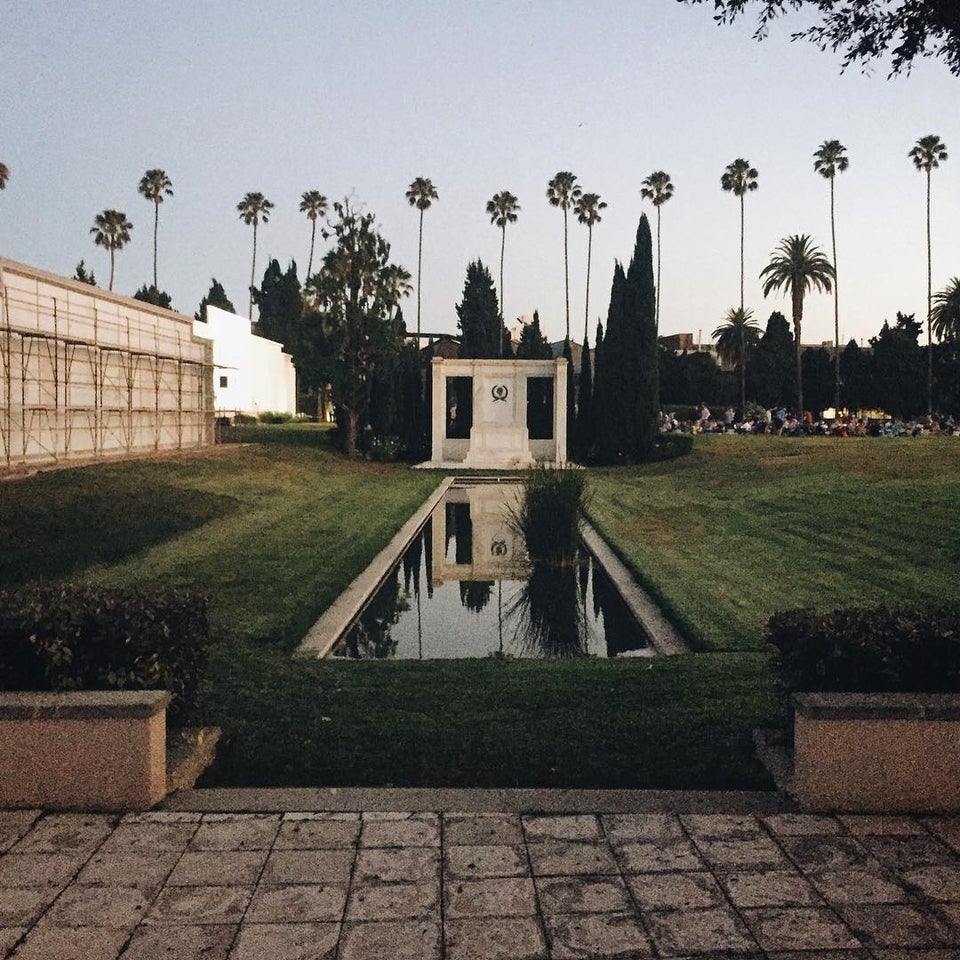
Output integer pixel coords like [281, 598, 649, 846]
[683, 0, 960, 76]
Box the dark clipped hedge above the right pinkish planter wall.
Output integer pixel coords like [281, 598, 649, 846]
[764, 604, 960, 693]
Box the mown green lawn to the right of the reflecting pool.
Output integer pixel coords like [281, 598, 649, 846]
[591, 436, 960, 650]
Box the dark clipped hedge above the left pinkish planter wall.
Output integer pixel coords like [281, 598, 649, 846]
[0, 585, 209, 716]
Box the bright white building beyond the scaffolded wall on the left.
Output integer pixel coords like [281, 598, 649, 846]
[193, 306, 297, 416]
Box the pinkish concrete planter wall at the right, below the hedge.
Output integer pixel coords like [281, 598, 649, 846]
[792, 693, 960, 813]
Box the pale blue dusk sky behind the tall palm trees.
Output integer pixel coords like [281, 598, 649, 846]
[0, 0, 960, 343]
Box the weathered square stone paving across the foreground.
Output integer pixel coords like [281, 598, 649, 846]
[0, 811, 960, 960]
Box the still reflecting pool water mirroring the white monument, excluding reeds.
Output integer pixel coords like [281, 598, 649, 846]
[333, 487, 653, 659]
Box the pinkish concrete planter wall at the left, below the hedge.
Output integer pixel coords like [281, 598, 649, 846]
[0, 690, 170, 810]
